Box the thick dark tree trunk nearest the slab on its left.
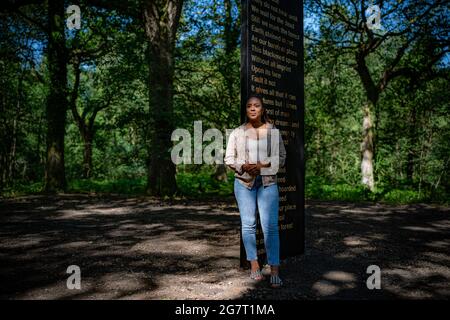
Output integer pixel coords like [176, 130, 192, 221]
[143, 0, 183, 196]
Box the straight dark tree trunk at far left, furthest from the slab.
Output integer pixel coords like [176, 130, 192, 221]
[45, 0, 67, 192]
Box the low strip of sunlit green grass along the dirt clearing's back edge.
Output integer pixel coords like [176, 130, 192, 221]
[2, 170, 450, 205]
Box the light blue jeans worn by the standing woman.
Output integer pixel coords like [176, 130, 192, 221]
[234, 175, 280, 265]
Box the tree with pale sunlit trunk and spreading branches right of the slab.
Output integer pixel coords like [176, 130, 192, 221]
[308, 0, 449, 191]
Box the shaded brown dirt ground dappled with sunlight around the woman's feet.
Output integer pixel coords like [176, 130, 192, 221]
[0, 195, 450, 299]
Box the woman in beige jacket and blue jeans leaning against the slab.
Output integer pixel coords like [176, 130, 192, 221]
[225, 95, 286, 288]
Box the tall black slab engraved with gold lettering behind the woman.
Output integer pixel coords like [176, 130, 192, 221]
[241, 0, 305, 267]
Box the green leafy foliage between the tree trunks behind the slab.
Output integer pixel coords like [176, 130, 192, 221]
[0, 0, 450, 203]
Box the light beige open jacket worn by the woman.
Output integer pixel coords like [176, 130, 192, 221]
[224, 123, 286, 189]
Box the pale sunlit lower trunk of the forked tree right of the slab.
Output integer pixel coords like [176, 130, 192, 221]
[361, 102, 375, 192]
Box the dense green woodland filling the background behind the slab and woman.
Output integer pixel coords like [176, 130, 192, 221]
[0, 0, 450, 203]
